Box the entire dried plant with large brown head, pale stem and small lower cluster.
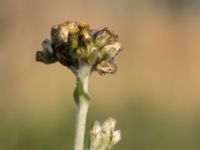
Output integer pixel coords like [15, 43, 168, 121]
[36, 21, 122, 150]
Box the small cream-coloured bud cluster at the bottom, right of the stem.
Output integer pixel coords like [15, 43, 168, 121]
[89, 118, 121, 150]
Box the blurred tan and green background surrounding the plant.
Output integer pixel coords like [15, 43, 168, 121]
[0, 0, 200, 150]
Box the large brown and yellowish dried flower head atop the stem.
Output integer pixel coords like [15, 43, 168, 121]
[36, 21, 122, 75]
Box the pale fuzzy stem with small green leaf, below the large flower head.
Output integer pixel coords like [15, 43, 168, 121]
[74, 65, 91, 150]
